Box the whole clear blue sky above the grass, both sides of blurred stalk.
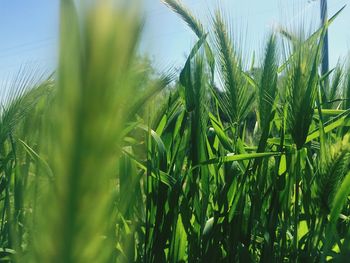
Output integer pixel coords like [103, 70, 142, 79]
[0, 0, 350, 81]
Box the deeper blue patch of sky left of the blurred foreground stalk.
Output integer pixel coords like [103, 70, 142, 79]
[0, 0, 59, 80]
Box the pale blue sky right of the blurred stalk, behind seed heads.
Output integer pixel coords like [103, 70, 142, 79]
[142, 0, 350, 69]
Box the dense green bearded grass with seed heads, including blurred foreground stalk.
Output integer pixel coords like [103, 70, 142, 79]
[0, 0, 350, 263]
